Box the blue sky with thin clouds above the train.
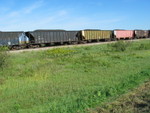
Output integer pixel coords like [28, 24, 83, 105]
[0, 0, 150, 31]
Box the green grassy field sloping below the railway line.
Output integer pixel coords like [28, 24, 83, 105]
[0, 40, 150, 113]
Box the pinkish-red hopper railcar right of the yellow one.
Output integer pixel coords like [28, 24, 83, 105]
[114, 30, 134, 39]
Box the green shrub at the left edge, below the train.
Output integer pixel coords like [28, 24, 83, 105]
[0, 47, 8, 68]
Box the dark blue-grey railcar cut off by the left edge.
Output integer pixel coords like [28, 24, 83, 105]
[0, 32, 23, 46]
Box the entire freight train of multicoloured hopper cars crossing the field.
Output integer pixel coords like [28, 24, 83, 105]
[0, 29, 150, 49]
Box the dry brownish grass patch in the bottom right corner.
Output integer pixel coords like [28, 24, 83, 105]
[88, 81, 150, 113]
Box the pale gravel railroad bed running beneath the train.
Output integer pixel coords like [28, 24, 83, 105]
[9, 38, 150, 53]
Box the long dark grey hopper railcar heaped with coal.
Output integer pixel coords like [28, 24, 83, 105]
[26, 30, 78, 44]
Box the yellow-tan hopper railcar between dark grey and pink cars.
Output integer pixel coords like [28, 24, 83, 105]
[81, 30, 112, 40]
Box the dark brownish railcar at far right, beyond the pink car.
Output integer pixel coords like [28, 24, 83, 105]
[135, 30, 149, 38]
